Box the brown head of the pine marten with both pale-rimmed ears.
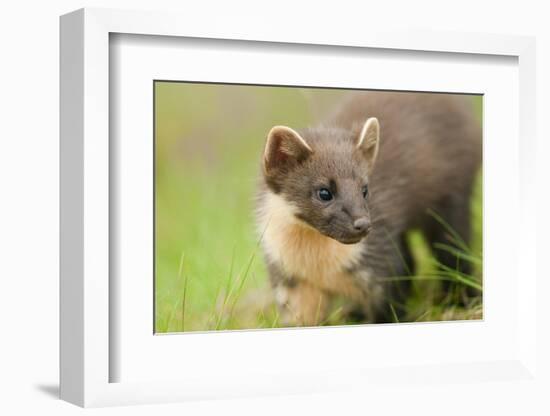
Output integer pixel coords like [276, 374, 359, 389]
[263, 118, 380, 244]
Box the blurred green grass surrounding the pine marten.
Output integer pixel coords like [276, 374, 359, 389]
[155, 82, 482, 332]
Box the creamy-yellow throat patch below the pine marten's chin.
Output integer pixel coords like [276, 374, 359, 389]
[258, 191, 364, 296]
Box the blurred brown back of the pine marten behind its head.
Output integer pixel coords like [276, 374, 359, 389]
[326, 92, 481, 232]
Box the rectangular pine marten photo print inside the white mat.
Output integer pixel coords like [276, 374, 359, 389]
[153, 81, 483, 333]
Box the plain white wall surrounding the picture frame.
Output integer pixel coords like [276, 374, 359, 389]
[0, 0, 550, 415]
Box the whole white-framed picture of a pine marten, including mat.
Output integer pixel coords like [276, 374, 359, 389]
[61, 9, 539, 406]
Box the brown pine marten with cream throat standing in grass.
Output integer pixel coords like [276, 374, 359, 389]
[258, 92, 481, 325]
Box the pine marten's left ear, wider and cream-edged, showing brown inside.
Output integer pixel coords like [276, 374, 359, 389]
[264, 126, 313, 173]
